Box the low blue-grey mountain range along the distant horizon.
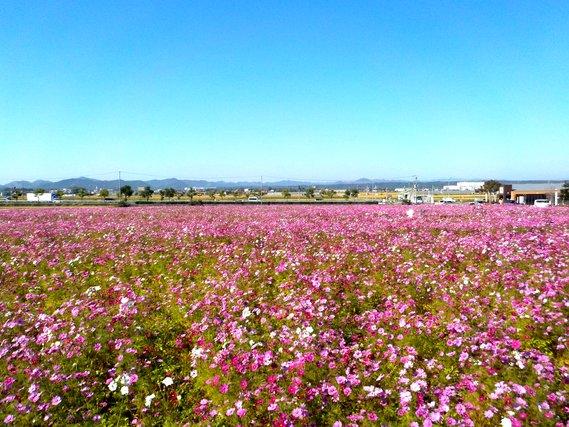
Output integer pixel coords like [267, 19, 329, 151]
[0, 177, 562, 191]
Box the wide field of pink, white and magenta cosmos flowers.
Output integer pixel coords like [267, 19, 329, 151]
[0, 206, 569, 427]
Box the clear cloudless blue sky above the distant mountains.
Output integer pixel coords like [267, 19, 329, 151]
[0, 0, 569, 183]
